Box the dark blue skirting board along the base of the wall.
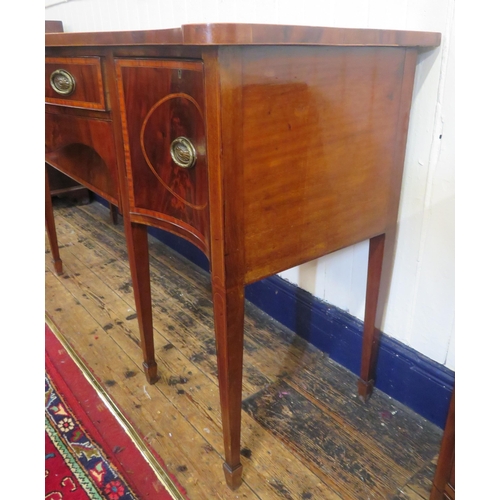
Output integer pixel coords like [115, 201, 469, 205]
[95, 200, 455, 429]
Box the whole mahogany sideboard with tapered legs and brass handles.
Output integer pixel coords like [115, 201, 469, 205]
[45, 24, 441, 489]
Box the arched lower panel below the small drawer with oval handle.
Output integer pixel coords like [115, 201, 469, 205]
[45, 113, 120, 206]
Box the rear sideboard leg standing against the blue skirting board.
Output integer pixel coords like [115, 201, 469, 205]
[358, 234, 385, 401]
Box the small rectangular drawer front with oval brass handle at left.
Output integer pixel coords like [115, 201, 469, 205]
[45, 57, 106, 110]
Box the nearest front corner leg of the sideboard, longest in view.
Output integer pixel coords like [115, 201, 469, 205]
[212, 284, 245, 490]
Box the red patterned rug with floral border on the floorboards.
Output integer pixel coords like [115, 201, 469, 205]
[45, 325, 187, 500]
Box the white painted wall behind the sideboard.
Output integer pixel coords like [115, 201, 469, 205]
[45, 0, 455, 370]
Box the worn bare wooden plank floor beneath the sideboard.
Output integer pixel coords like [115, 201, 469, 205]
[46, 202, 442, 500]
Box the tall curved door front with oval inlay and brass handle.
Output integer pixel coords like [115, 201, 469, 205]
[115, 59, 208, 248]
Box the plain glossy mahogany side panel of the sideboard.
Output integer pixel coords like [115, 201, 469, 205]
[243, 47, 406, 283]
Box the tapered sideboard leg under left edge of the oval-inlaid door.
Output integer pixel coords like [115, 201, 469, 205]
[124, 221, 159, 384]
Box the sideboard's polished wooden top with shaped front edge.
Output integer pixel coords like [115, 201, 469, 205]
[45, 23, 441, 47]
